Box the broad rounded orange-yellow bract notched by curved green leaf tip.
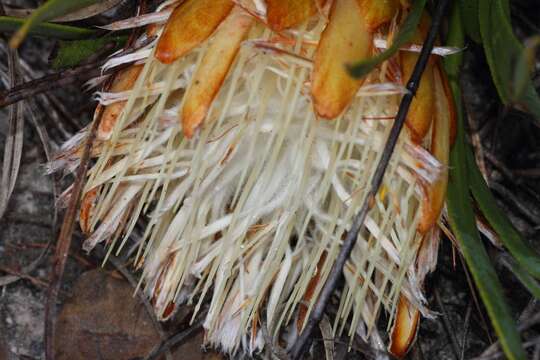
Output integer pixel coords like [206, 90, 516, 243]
[311, 0, 372, 119]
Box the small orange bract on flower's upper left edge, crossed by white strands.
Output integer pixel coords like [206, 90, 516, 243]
[96, 65, 143, 140]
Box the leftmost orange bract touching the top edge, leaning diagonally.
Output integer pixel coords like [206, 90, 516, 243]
[156, 0, 234, 64]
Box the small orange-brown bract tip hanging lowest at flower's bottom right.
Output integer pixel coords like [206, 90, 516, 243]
[388, 295, 420, 359]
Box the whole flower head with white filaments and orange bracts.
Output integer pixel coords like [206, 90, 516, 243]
[51, 0, 454, 356]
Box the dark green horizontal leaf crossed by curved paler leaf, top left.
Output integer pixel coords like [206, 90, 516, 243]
[0, 16, 96, 40]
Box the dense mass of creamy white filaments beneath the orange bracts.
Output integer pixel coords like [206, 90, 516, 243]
[51, 12, 441, 352]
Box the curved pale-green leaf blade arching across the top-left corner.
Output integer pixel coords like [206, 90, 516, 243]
[9, 0, 100, 49]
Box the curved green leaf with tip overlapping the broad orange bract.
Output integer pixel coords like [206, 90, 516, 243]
[346, 0, 426, 78]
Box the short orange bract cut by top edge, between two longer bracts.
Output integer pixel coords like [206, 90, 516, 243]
[266, 0, 317, 31]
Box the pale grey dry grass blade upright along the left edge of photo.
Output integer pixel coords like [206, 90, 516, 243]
[0, 44, 24, 218]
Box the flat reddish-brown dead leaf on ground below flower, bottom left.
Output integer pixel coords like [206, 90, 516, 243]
[55, 270, 160, 360]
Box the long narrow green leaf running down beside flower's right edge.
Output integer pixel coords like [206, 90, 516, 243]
[445, 6, 526, 360]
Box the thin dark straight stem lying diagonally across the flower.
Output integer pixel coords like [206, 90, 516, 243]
[290, 0, 448, 360]
